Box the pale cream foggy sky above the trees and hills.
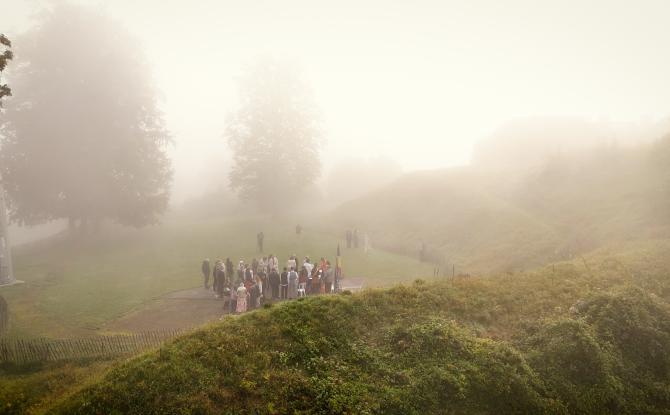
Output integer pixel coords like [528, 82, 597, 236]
[0, 0, 670, 202]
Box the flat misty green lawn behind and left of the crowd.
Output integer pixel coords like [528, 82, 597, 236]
[2, 219, 432, 337]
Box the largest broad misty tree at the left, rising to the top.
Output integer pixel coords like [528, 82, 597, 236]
[0, 3, 171, 231]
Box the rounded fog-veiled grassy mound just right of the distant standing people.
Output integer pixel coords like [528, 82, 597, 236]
[327, 168, 560, 273]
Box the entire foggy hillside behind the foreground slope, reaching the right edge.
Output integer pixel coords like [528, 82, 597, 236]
[328, 130, 670, 273]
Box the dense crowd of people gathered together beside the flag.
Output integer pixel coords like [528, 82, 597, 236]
[201, 255, 340, 313]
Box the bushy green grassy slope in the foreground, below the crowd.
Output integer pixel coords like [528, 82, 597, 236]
[35, 240, 670, 414]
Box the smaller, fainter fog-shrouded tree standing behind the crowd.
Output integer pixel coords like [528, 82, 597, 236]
[225, 58, 322, 213]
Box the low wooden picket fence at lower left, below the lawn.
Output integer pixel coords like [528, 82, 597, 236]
[0, 330, 182, 364]
